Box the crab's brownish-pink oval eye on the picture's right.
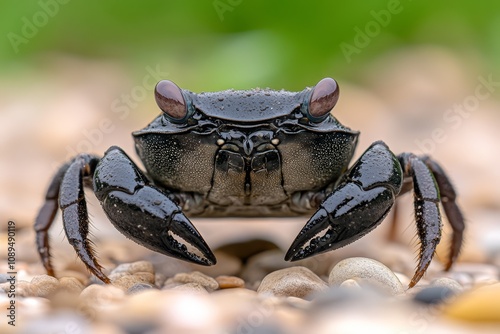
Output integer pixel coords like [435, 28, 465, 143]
[309, 78, 339, 121]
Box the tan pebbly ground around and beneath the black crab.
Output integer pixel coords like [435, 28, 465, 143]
[0, 48, 500, 334]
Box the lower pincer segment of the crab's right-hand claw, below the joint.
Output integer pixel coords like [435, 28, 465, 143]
[285, 182, 394, 261]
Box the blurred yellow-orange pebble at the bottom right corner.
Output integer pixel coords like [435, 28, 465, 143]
[443, 283, 500, 323]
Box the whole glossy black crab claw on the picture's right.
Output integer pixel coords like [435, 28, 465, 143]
[285, 142, 402, 261]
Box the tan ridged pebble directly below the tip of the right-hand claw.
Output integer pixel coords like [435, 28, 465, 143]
[257, 267, 328, 298]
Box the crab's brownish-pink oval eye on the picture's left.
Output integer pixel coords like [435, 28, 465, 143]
[155, 80, 187, 121]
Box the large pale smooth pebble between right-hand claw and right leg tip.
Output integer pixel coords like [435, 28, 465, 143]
[328, 257, 404, 295]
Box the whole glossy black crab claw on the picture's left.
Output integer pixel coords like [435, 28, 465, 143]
[94, 147, 216, 266]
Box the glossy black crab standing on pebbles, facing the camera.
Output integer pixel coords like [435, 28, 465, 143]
[35, 78, 464, 287]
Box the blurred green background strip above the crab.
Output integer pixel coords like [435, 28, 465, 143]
[0, 0, 500, 91]
